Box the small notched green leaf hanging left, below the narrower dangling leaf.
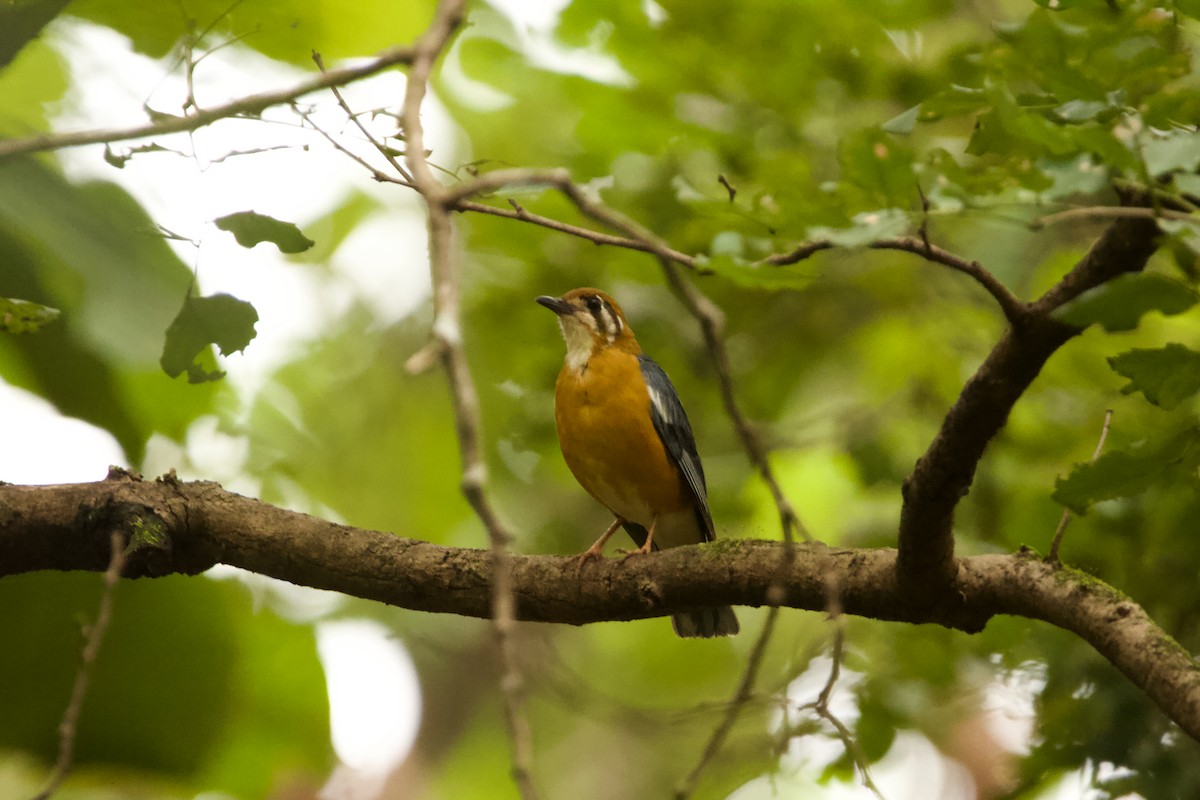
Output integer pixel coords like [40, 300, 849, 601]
[160, 294, 258, 384]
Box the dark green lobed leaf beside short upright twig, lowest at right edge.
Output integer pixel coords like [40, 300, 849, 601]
[1052, 427, 1200, 513]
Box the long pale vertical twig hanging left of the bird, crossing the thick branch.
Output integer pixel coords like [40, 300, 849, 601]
[401, 0, 538, 800]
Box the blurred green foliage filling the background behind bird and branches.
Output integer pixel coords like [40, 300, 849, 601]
[0, 0, 1200, 799]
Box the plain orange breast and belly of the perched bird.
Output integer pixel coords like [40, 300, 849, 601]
[554, 348, 691, 528]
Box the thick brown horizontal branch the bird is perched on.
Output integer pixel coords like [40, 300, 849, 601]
[0, 477, 1200, 740]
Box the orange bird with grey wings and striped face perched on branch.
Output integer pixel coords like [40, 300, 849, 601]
[536, 287, 738, 638]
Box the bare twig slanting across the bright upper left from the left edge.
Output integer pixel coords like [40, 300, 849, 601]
[0, 47, 413, 161]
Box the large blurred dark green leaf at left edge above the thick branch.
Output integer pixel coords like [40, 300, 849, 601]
[0, 155, 216, 465]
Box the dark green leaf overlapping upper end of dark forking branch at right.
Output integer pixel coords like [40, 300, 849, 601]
[1054, 272, 1198, 332]
